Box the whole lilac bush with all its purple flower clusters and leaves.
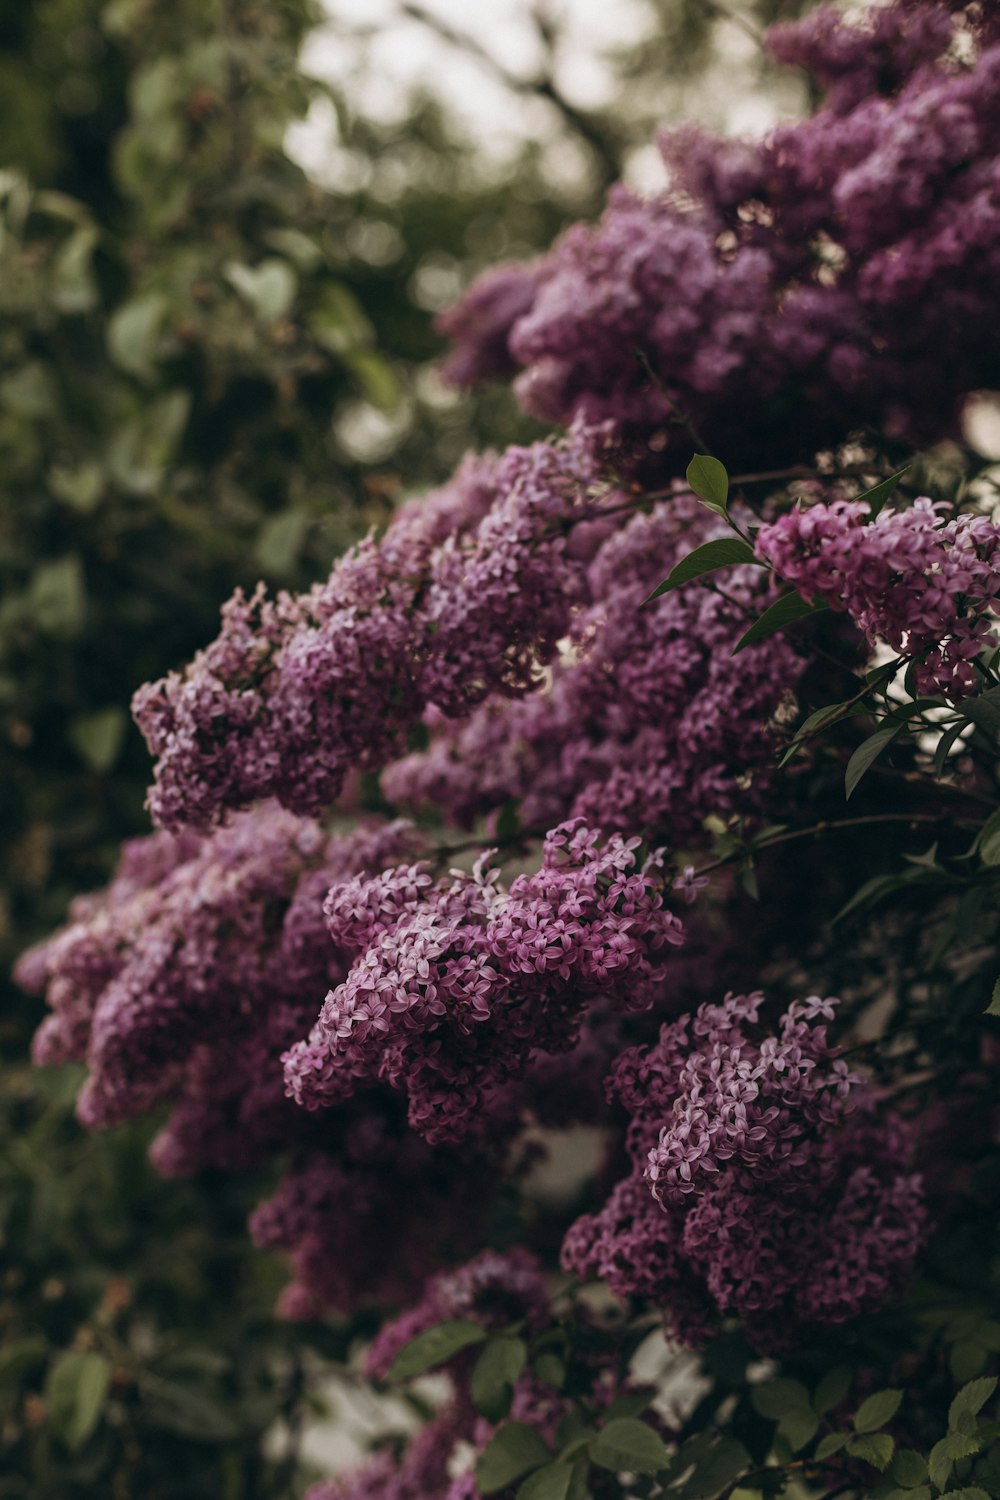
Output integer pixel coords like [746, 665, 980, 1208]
[19, 0, 1000, 1500]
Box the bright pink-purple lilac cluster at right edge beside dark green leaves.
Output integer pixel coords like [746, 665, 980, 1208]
[757, 500, 1000, 701]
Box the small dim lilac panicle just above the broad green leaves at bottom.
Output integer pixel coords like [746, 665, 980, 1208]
[364, 1247, 549, 1380]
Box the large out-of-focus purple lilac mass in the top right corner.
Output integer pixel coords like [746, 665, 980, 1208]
[445, 0, 1000, 473]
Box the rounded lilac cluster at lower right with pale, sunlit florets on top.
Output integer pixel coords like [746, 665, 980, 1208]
[564, 993, 927, 1352]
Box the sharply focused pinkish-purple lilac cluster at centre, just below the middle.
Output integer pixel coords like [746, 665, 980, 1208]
[285, 824, 684, 1142]
